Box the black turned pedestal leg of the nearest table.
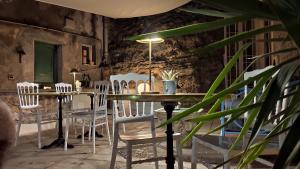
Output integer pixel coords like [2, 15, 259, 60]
[163, 102, 177, 169]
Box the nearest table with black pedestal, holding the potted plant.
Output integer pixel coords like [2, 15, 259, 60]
[107, 93, 206, 169]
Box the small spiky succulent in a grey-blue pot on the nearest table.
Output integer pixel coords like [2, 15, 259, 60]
[161, 69, 179, 94]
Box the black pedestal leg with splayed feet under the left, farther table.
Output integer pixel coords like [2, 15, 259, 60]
[42, 95, 74, 149]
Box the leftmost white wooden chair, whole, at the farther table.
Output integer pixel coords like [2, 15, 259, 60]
[16, 82, 55, 148]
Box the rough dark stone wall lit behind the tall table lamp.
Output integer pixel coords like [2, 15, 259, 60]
[108, 7, 224, 92]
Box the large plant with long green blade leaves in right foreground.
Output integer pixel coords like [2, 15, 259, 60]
[129, 0, 300, 169]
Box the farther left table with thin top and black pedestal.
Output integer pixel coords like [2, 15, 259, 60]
[25, 91, 95, 149]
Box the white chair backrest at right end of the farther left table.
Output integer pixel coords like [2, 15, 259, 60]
[94, 81, 110, 112]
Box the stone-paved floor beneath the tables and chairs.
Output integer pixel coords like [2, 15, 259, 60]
[3, 119, 209, 169]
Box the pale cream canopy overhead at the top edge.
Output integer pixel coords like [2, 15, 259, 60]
[38, 0, 191, 18]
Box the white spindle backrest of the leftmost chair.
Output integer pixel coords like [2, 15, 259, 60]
[17, 82, 39, 109]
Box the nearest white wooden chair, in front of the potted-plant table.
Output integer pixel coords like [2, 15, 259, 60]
[110, 73, 182, 169]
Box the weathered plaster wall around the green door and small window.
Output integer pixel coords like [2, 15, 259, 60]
[0, 0, 102, 89]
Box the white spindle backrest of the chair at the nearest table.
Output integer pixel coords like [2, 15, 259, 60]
[110, 73, 155, 122]
